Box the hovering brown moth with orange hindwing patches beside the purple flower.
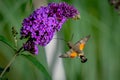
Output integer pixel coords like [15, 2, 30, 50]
[59, 35, 90, 63]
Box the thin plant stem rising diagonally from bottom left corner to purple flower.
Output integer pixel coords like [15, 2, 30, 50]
[0, 47, 23, 79]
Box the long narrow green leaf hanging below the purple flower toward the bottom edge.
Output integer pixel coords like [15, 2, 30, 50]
[22, 54, 51, 80]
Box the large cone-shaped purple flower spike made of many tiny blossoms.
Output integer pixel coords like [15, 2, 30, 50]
[21, 2, 79, 54]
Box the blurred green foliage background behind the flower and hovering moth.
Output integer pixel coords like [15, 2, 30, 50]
[0, 0, 120, 80]
